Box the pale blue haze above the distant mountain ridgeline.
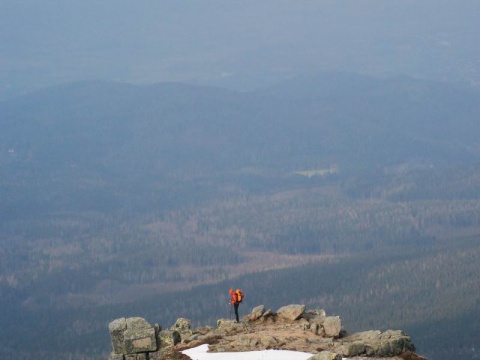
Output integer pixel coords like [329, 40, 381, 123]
[0, 0, 480, 96]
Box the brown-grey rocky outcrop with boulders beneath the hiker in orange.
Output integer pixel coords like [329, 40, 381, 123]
[109, 304, 424, 360]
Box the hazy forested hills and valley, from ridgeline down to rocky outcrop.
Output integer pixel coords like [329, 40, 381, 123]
[0, 74, 480, 360]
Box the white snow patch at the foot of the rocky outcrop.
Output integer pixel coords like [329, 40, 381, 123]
[182, 344, 313, 360]
